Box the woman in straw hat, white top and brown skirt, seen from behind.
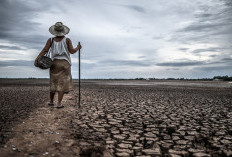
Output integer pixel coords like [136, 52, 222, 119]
[34, 22, 82, 108]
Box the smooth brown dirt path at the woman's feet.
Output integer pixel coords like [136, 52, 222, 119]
[0, 92, 80, 157]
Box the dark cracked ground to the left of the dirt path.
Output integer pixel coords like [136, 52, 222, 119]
[0, 81, 49, 146]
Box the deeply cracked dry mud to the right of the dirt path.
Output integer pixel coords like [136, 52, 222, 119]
[75, 81, 232, 156]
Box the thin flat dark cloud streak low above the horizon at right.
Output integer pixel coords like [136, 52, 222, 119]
[156, 61, 205, 67]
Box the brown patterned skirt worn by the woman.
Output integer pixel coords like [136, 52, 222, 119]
[50, 59, 73, 93]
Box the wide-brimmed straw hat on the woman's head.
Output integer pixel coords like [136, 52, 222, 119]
[49, 22, 70, 36]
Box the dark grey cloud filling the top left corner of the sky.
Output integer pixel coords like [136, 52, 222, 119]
[0, 0, 49, 48]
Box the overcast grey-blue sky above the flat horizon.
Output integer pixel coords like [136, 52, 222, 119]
[0, 0, 232, 78]
